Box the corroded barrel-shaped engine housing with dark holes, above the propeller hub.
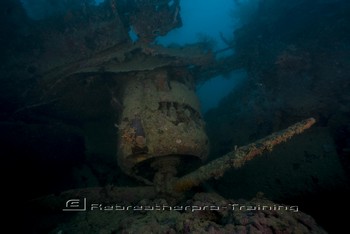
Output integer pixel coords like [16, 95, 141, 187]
[118, 68, 209, 181]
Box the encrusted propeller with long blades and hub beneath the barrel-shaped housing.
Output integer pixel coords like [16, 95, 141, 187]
[35, 118, 315, 210]
